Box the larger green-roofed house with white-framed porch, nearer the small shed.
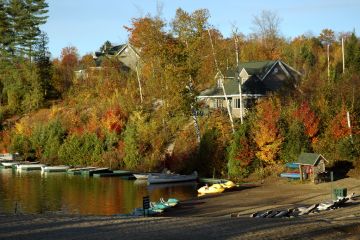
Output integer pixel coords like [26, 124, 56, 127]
[198, 60, 301, 118]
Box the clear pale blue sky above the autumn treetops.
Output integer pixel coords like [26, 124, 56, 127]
[42, 0, 360, 57]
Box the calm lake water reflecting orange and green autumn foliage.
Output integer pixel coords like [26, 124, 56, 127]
[0, 169, 197, 215]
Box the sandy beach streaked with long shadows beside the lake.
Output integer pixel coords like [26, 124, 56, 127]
[0, 178, 360, 239]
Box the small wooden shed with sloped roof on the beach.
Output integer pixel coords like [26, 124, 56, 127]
[295, 153, 328, 182]
